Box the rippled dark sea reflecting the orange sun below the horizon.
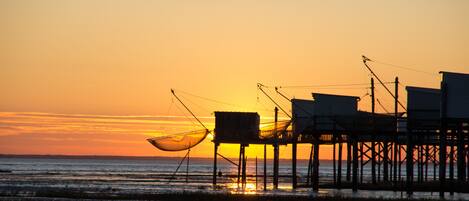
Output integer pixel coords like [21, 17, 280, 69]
[0, 155, 469, 200]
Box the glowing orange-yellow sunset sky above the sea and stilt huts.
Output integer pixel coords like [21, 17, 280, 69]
[0, 0, 469, 159]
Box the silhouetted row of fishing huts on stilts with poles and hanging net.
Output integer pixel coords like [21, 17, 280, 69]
[144, 56, 469, 197]
